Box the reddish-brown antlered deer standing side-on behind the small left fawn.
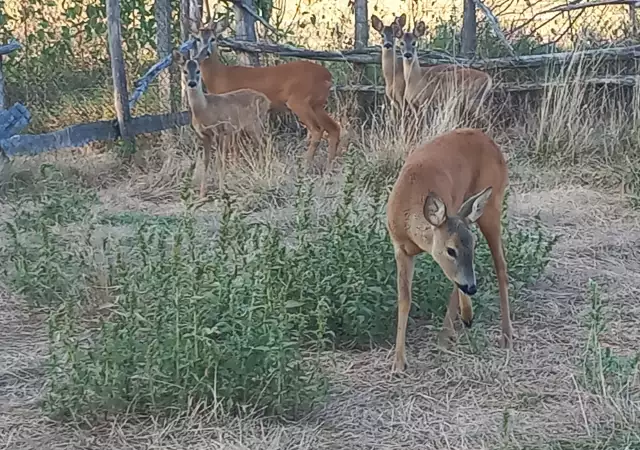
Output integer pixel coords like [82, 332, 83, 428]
[193, 16, 340, 167]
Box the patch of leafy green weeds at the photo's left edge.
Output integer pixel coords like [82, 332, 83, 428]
[0, 165, 97, 307]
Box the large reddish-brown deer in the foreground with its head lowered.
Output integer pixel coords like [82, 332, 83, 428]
[387, 128, 512, 372]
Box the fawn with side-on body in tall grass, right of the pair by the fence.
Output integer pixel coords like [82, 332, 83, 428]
[396, 21, 493, 119]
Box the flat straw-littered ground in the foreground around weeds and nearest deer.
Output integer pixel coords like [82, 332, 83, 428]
[0, 171, 640, 450]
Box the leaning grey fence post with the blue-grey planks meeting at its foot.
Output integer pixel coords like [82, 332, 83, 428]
[107, 0, 135, 151]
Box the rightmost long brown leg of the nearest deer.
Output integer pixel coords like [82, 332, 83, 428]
[478, 202, 513, 348]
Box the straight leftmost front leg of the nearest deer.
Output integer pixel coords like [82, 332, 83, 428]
[392, 247, 414, 373]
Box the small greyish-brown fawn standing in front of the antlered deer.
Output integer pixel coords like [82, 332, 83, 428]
[173, 48, 271, 197]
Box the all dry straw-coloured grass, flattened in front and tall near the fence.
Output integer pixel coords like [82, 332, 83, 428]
[0, 59, 640, 450]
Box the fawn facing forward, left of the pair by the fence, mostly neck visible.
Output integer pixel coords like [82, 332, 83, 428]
[371, 14, 407, 110]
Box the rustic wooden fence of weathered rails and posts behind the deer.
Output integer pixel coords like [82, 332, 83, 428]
[0, 0, 640, 158]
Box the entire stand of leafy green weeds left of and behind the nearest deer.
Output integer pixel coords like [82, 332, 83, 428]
[5, 163, 553, 419]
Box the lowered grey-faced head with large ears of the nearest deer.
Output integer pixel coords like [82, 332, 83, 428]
[424, 186, 492, 295]
